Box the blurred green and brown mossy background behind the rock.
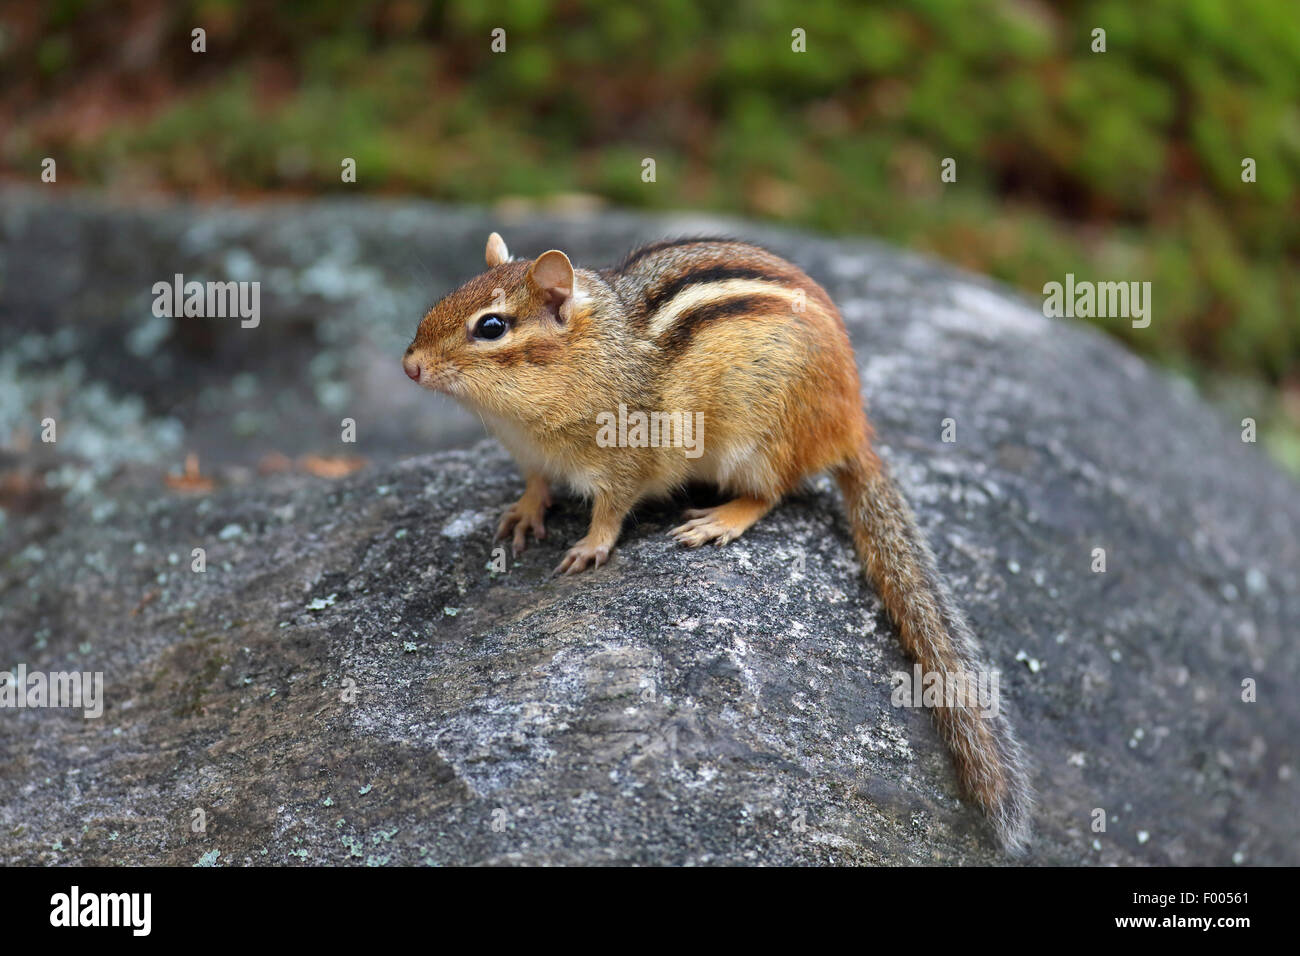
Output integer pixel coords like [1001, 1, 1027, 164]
[0, 0, 1300, 473]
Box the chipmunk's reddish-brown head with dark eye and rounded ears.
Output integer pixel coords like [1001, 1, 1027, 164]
[402, 233, 588, 419]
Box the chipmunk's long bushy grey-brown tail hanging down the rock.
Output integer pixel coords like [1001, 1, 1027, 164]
[835, 445, 1034, 853]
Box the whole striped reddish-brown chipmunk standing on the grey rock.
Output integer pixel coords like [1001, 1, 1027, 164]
[402, 233, 1032, 852]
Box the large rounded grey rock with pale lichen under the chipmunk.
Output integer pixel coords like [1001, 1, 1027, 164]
[0, 194, 1300, 865]
